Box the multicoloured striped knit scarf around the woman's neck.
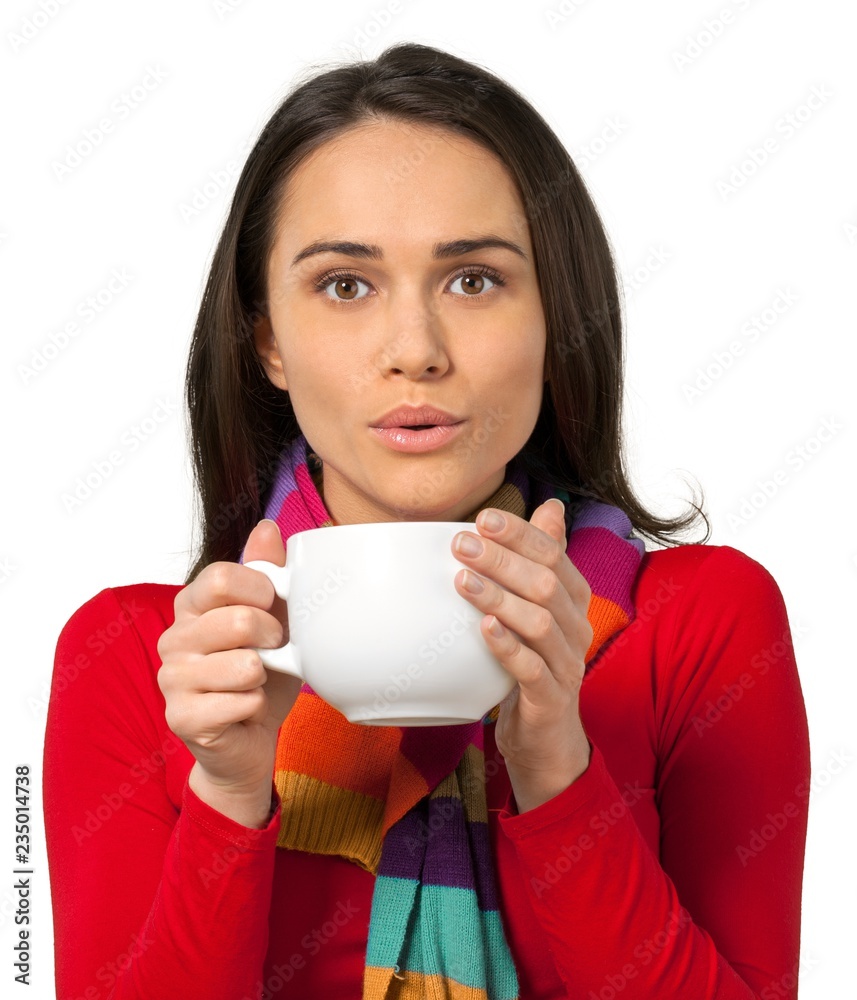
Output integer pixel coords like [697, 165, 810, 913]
[239, 436, 644, 1000]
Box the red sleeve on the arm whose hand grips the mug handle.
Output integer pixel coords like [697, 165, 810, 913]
[43, 588, 280, 1000]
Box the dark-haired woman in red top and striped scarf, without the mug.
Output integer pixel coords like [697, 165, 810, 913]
[44, 44, 809, 1000]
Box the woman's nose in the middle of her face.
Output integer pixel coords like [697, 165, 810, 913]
[377, 303, 450, 379]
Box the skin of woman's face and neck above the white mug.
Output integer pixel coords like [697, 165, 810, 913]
[256, 123, 546, 524]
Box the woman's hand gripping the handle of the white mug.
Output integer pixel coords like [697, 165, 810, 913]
[158, 520, 301, 827]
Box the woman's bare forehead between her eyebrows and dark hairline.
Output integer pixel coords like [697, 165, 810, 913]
[268, 122, 529, 257]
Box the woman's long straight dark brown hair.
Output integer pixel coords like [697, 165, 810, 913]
[185, 43, 710, 584]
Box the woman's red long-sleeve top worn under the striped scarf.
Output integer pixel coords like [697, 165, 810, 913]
[43, 545, 810, 1000]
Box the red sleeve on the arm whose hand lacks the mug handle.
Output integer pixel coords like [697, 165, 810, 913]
[498, 546, 810, 1000]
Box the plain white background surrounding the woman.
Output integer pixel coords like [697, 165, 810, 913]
[0, 0, 857, 1000]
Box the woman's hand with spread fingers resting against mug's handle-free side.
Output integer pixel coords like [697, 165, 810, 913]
[452, 500, 593, 812]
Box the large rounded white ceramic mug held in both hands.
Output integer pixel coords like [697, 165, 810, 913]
[245, 521, 515, 726]
